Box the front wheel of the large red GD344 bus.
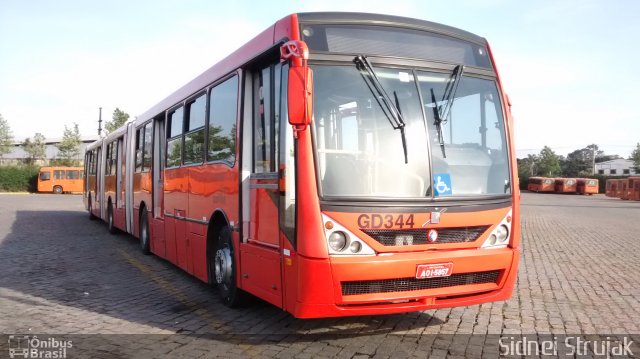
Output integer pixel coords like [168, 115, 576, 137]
[212, 225, 246, 308]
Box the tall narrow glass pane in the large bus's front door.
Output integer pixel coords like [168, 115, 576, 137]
[253, 66, 275, 173]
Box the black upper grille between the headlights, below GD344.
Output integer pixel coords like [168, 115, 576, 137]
[362, 226, 489, 246]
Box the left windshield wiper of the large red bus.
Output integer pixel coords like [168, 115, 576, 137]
[353, 55, 409, 163]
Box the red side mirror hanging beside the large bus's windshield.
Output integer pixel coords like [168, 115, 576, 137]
[280, 40, 313, 130]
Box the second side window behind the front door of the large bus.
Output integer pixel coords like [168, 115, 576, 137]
[183, 94, 207, 164]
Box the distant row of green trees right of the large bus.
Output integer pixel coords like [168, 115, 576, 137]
[518, 143, 640, 178]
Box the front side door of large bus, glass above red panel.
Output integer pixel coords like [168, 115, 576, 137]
[240, 65, 283, 307]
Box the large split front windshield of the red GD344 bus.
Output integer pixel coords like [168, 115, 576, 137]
[312, 64, 511, 199]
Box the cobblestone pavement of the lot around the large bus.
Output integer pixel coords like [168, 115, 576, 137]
[0, 193, 640, 358]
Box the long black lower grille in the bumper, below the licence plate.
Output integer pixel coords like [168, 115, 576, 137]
[341, 270, 500, 295]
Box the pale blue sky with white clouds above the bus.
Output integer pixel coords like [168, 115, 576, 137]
[0, 0, 640, 157]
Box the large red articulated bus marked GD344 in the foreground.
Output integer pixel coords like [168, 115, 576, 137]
[84, 13, 520, 318]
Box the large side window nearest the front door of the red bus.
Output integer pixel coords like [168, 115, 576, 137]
[207, 76, 238, 164]
